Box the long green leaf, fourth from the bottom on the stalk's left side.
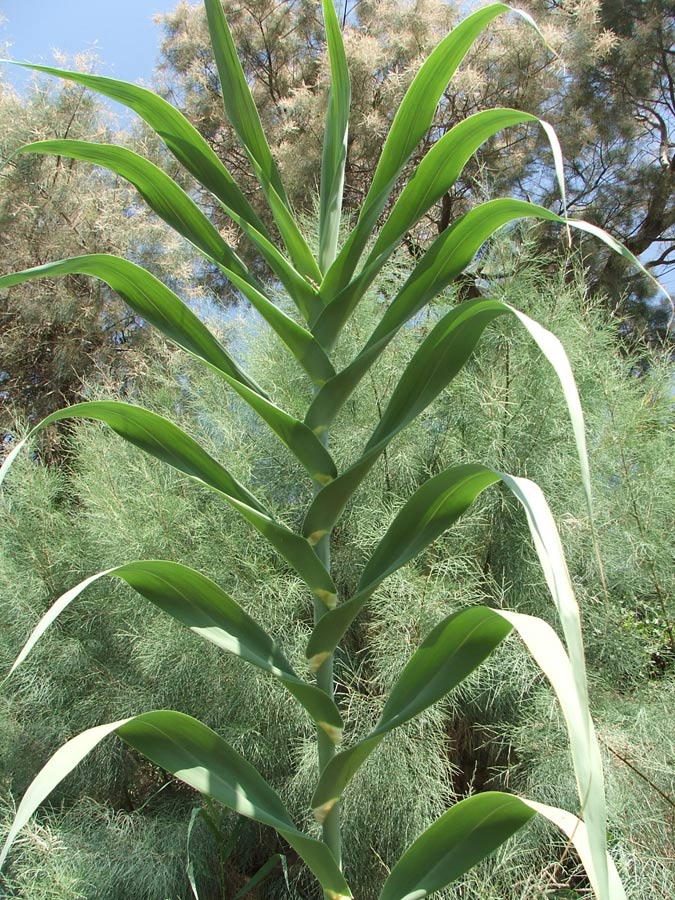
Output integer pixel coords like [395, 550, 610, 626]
[0, 254, 337, 484]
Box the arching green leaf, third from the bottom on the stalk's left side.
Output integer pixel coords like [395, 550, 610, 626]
[0, 401, 336, 606]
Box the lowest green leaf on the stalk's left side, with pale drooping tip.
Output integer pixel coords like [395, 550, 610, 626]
[0, 710, 352, 900]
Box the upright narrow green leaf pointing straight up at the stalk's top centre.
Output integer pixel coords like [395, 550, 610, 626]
[319, 0, 351, 272]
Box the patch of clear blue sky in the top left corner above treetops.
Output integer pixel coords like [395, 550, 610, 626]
[0, 0, 182, 85]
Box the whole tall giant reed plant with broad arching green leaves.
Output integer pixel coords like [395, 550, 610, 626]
[0, 0, 660, 900]
